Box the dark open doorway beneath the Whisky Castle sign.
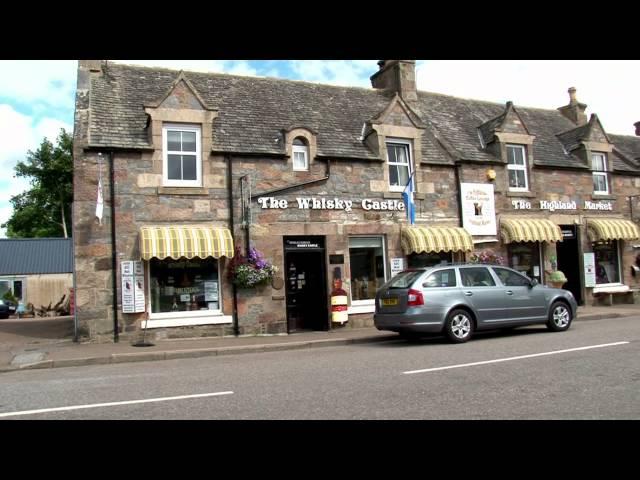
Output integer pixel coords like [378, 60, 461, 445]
[284, 236, 329, 333]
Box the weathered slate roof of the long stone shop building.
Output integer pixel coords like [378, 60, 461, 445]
[89, 63, 640, 170]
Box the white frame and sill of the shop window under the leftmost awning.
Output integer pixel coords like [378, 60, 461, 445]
[142, 259, 233, 328]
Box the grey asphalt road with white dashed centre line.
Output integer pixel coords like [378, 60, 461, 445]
[0, 316, 640, 420]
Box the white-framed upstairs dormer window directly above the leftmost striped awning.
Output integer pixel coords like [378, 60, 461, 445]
[162, 125, 202, 187]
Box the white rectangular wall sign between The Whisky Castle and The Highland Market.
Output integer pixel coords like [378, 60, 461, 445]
[460, 183, 496, 235]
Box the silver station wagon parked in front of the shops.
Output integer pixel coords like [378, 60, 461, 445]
[373, 263, 578, 343]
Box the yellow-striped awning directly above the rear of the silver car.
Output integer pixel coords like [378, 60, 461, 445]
[400, 226, 473, 255]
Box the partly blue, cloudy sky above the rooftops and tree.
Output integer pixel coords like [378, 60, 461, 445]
[0, 60, 640, 237]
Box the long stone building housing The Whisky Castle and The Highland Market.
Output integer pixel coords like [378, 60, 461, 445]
[74, 60, 640, 341]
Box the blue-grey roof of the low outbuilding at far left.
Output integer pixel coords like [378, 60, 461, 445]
[0, 238, 73, 275]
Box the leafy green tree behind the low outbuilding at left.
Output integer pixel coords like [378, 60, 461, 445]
[1, 129, 73, 238]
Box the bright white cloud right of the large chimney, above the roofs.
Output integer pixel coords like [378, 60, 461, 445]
[416, 60, 640, 135]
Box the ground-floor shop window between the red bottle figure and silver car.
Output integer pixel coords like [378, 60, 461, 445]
[349, 237, 385, 305]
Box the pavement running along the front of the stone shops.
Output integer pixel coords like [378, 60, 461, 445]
[0, 304, 640, 372]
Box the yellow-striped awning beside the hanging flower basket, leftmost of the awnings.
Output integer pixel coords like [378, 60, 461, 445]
[140, 225, 233, 260]
